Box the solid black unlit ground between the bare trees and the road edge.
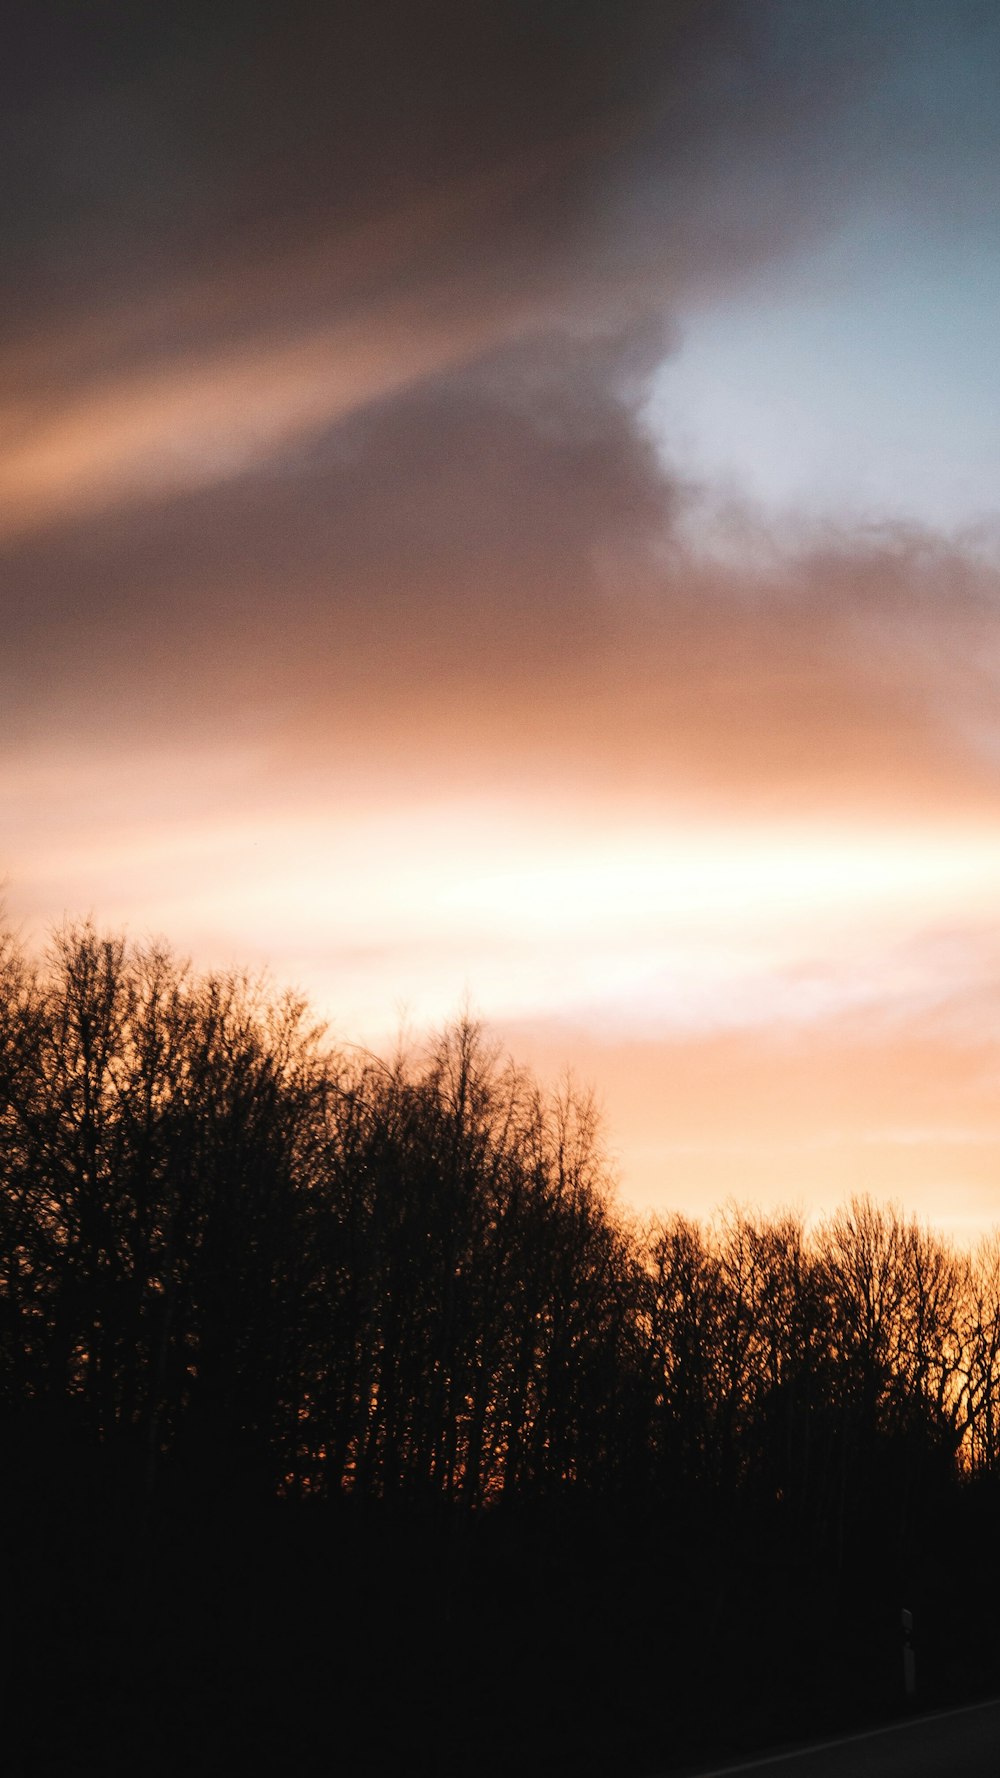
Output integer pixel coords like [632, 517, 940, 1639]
[0, 1470, 1000, 1778]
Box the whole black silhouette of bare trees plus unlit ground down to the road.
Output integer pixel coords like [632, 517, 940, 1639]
[0, 925, 1000, 1774]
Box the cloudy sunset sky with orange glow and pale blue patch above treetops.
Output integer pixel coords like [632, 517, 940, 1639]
[0, 0, 1000, 1237]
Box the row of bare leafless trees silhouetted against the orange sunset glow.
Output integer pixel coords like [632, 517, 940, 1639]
[0, 926, 1000, 1514]
